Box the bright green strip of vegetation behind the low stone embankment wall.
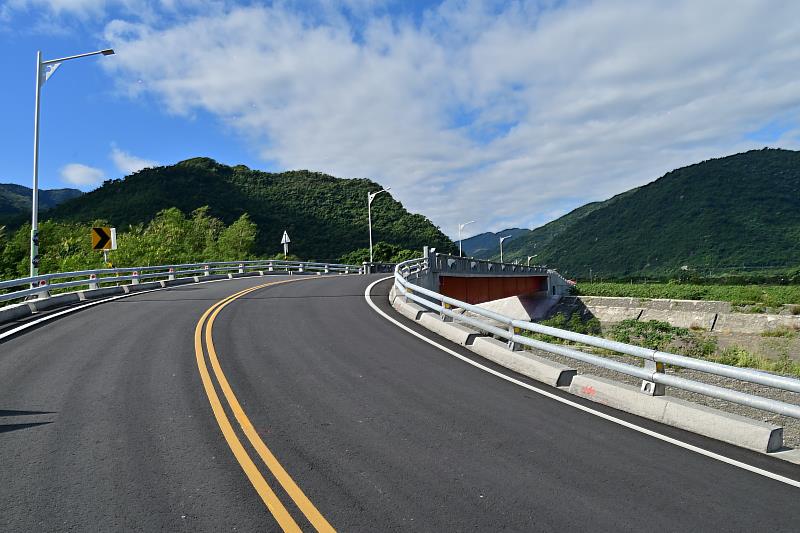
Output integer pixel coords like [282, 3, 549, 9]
[577, 282, 800, 306]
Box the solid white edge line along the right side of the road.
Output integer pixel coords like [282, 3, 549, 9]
[364, 276, 800, 488]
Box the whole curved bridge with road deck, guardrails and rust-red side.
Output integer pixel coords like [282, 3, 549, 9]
[0, 256, 800, 531]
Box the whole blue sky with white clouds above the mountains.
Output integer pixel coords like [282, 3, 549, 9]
[0, 0, 800, 235]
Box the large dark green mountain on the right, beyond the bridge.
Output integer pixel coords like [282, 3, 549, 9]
[490, 149, 800, 278]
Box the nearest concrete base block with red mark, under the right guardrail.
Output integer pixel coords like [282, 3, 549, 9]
[569, 374, 783, 453]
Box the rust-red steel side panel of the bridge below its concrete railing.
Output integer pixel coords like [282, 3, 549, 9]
[439, 276, 547, 304]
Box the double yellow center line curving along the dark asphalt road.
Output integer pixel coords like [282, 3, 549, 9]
[194, 280, 334, 532]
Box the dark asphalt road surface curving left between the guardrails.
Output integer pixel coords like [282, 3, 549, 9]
[0, 276, 800, 531]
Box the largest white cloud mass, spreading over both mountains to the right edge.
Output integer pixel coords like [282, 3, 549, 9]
[90, 0, 800, 234]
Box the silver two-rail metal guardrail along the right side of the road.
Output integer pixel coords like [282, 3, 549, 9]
[394, 258, 800, 419]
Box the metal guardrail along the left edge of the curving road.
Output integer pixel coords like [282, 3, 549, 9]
[0, 260, 363, 302]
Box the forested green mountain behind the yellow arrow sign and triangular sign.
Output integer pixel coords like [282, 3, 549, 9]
[42, 157, 454, 261]
